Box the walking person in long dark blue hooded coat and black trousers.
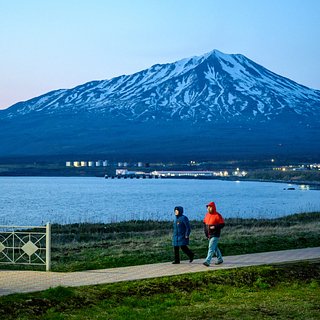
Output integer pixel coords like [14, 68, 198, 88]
[172, 207, 194, 264]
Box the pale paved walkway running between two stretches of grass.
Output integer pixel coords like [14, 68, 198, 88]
[0, 247, 320, 295]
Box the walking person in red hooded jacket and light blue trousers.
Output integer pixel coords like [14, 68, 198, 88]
[203, 202, 225, 267]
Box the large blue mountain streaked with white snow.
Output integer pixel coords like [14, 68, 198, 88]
[0, 50, 320, 158]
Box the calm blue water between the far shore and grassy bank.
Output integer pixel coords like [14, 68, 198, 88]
[0, 177, 320, 226]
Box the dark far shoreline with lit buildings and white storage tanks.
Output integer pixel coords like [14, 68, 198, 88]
[0, 156, 320, 185]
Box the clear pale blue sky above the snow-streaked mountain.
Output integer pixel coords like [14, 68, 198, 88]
[0, 0, 320, 109]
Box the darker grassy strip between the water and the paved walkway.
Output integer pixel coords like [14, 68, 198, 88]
[0, 212, 320, 271]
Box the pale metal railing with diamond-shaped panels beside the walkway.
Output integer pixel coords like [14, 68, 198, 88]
[0, 223, 51, 271]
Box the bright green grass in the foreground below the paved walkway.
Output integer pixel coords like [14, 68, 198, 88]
[0, 262, 320, 320]
